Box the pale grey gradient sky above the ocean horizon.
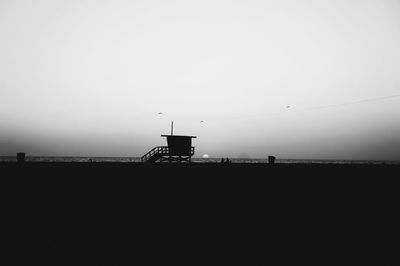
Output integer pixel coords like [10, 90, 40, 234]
[0, 0, 400, 160]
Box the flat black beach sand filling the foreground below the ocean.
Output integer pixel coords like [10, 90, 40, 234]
[0, 163, 400, 265]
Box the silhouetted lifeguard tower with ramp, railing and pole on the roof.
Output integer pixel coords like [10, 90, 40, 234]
[142, 122, 196, 163]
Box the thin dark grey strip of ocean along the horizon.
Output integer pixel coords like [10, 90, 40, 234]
[0, 156, 400, 164]
